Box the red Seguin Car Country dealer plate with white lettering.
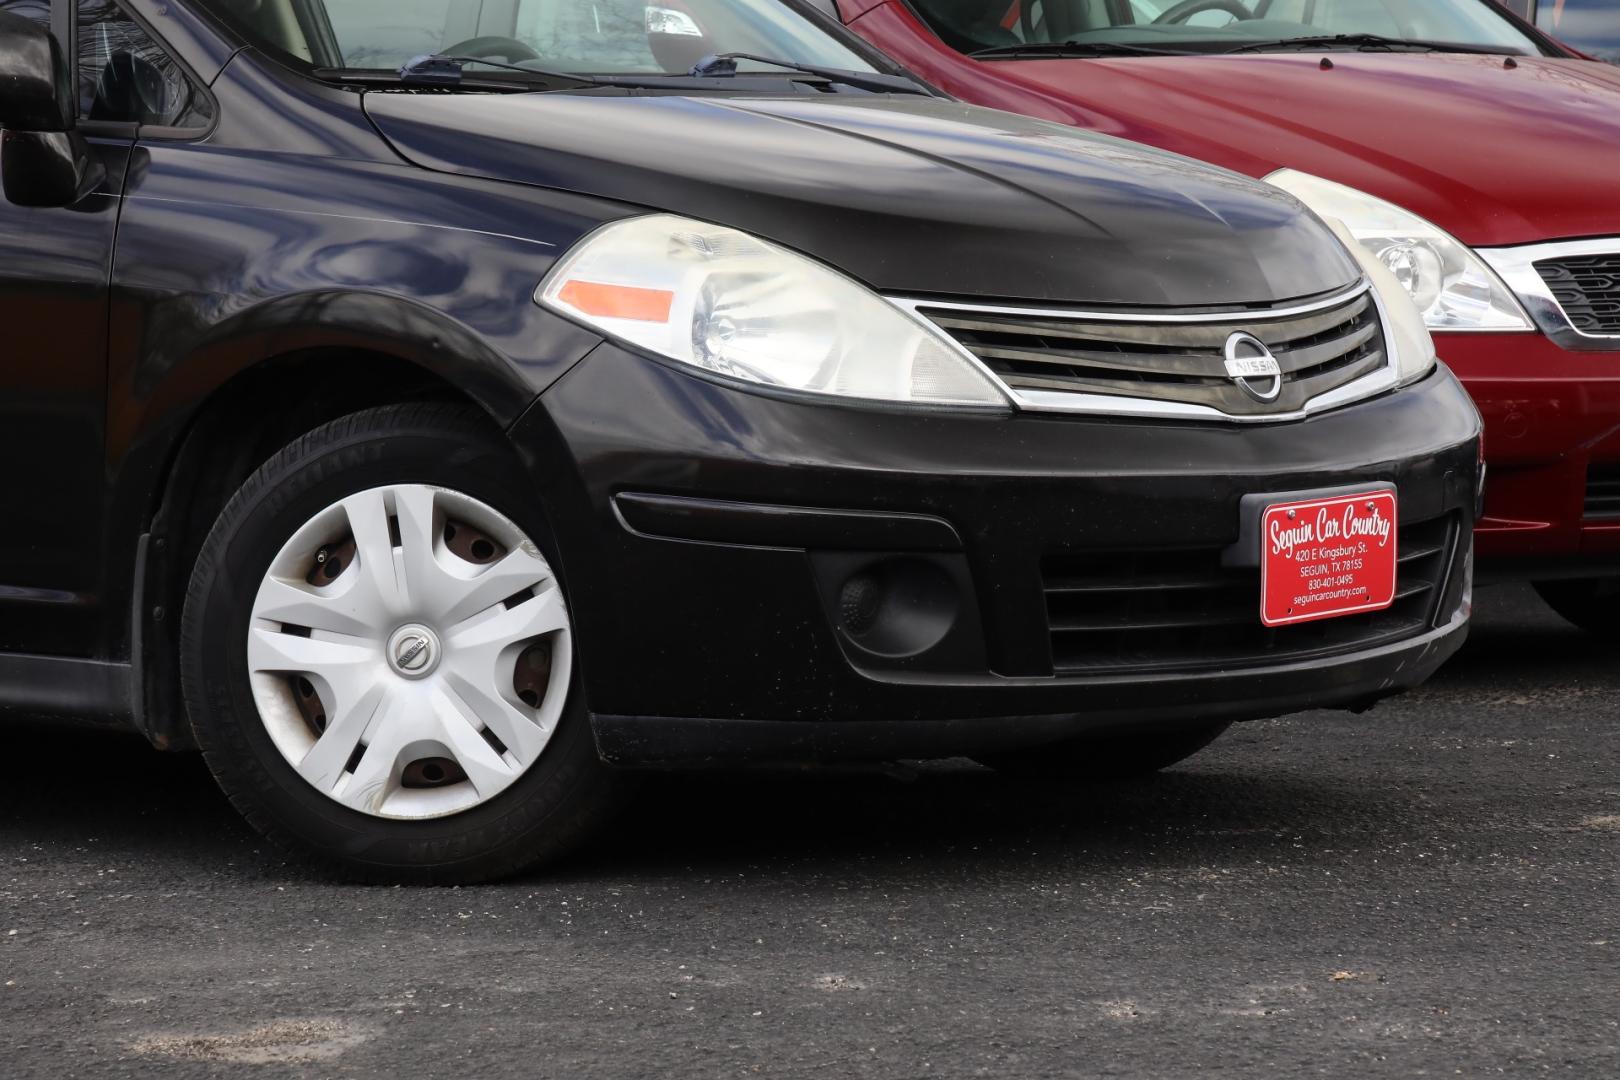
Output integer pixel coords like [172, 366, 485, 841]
[1260, 491, 1395, 627]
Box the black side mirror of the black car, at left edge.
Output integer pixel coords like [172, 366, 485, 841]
[0, 11, 107, 206]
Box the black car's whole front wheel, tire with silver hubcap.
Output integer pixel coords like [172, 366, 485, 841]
[180, 405, 622, 884]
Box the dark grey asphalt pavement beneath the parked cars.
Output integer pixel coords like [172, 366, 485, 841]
[0, 588, 1620, 1080]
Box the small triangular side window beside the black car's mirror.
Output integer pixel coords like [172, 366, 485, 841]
[79, 0, 214, 128]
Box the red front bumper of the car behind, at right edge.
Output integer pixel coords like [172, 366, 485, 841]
[1435, 334, 1620, 578]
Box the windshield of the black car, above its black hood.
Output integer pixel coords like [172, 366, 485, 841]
[203, 0, 875, 79]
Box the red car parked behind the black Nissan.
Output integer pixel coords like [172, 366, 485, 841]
[816, 0, 1620, 635]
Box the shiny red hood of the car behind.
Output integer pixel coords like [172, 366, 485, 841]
[985, 52, 1620, 246]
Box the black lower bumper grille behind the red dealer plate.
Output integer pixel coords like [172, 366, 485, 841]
[1042, 517, 1456, 675]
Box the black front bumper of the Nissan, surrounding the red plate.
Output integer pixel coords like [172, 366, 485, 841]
[512, 345, 1479, 764]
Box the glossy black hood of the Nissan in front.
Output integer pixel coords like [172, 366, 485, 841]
[365, 92, 1359, 306]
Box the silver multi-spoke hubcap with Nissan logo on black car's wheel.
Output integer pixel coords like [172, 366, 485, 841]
[248, 484, 573, 819]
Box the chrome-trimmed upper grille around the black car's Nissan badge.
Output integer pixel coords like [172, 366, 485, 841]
[914, 288, 1388, 418]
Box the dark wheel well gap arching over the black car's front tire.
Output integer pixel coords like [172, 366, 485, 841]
[133, 350, 498, 748]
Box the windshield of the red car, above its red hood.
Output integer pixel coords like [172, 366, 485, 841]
[907, 0, 1541, 57]
